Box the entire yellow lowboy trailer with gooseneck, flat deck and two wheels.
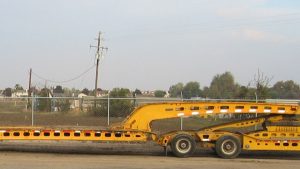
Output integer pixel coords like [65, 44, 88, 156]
[0, 102, 300, 158]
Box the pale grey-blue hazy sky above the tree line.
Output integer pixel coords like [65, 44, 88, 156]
[0, 0, 300, 90]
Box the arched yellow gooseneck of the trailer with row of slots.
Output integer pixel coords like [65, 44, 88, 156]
[114, 102, 300, 132]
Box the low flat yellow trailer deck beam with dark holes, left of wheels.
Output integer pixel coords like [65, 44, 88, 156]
[0, 128, 152, 142]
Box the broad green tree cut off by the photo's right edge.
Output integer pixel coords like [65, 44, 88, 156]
[270, 80, 300, 99]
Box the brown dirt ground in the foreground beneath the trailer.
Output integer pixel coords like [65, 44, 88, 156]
[0, 142, 300, 169]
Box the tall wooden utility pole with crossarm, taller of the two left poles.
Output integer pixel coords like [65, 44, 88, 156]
[90, 32, 108, 108]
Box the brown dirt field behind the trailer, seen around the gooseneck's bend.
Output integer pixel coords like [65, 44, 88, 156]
[0, 112, 237, 134]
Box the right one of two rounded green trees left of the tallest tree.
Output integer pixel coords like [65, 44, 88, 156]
[182, 82, 201, 99]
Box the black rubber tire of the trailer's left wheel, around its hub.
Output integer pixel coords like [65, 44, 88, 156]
[171, 134, 196, 158]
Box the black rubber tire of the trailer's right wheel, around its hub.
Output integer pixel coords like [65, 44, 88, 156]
[215, 135, 242, 159]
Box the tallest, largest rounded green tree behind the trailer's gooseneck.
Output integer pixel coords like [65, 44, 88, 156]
[209, 72, 237, 99]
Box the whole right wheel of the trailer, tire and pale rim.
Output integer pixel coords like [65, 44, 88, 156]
[215, 136, 242, 159]
